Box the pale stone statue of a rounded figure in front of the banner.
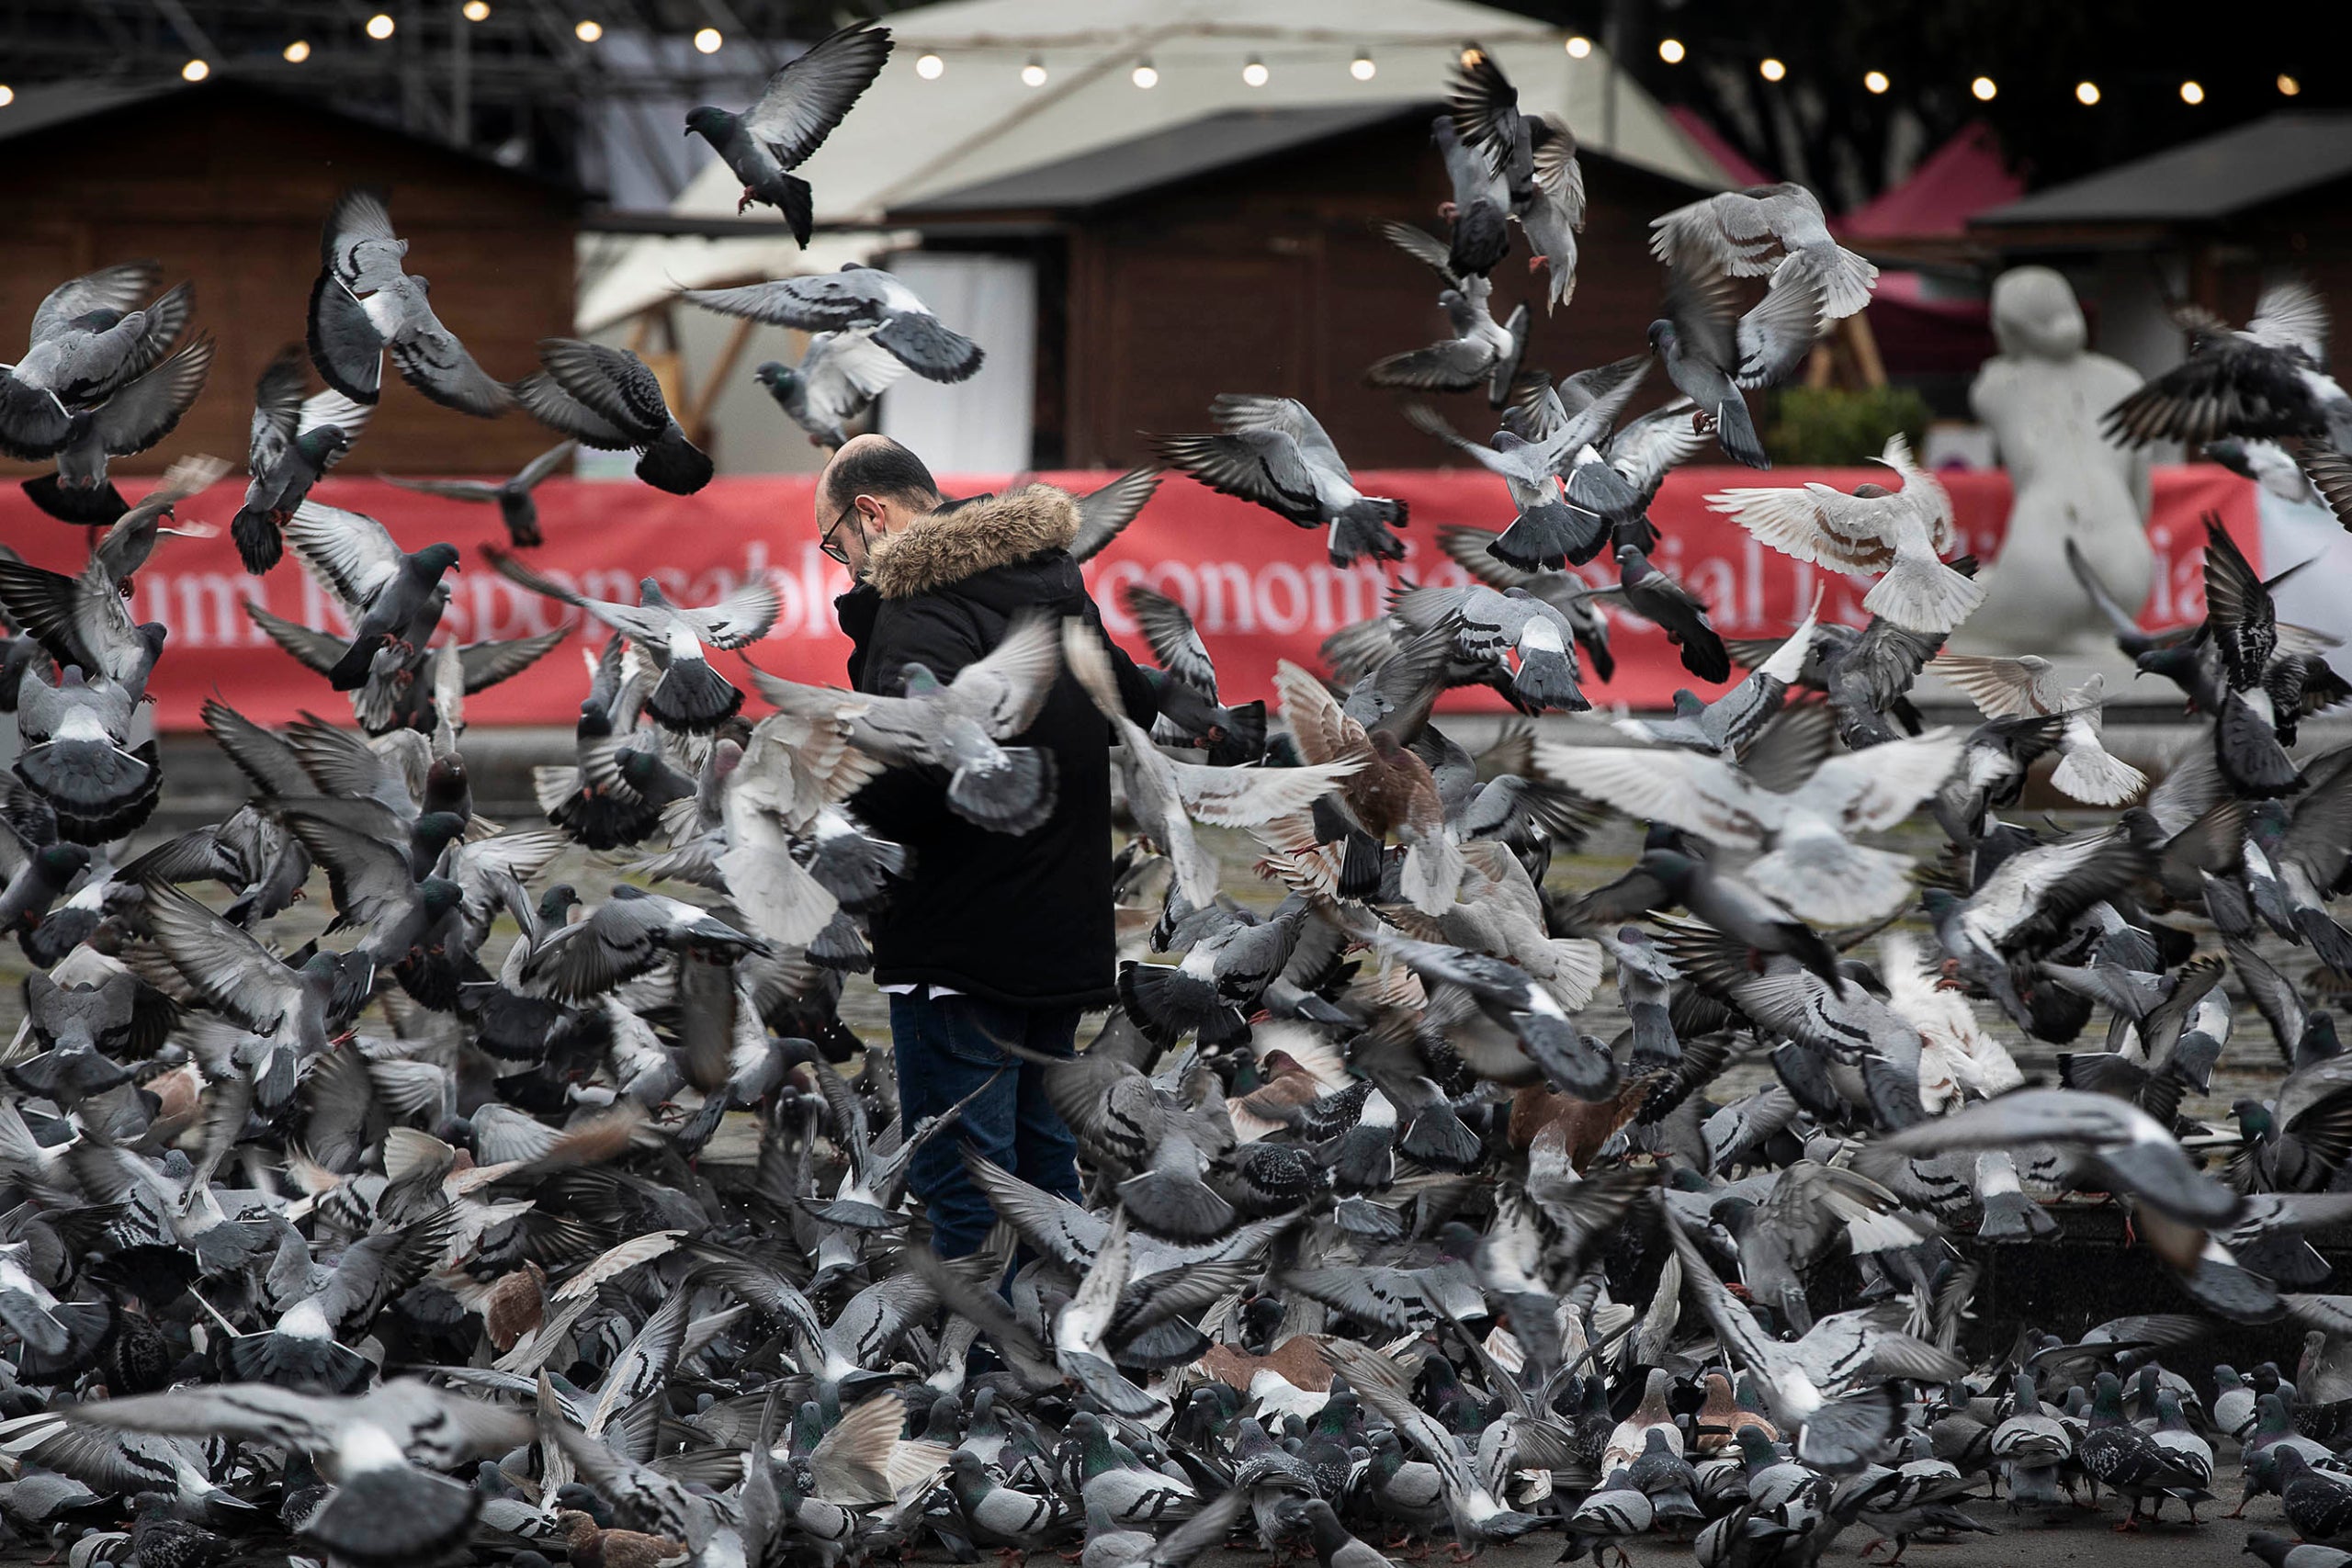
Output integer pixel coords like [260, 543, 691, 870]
[1952, 265, 2154, 659]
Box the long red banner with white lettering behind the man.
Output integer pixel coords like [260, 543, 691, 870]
[0, 466, 2260, 728]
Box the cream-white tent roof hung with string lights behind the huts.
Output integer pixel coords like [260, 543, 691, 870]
[579, 0, 1731, 332]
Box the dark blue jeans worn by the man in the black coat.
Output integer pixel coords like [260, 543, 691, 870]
[889, 995, 1077, 1258]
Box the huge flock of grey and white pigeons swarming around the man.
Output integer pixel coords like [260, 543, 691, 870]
[0, 26, 2352, 1568]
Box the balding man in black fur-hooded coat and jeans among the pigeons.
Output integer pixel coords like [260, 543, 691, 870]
[816, 434, 1158, 1258]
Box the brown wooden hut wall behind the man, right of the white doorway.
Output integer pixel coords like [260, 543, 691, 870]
[1068, 111, 1696, 468]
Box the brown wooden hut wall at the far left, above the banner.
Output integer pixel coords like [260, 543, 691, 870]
[0, 85, 574, 475]
